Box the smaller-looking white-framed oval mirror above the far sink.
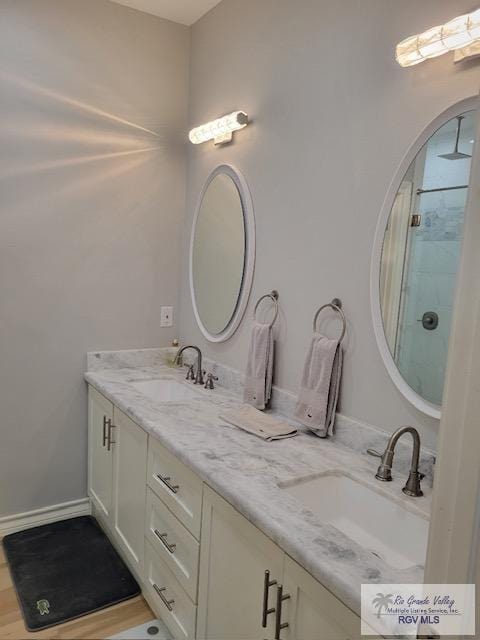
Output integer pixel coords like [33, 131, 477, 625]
[190, 165, 255, 342]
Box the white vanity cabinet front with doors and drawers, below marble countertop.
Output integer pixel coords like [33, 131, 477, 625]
[88, 387, 360, 640]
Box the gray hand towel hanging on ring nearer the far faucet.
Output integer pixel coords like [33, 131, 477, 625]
[243, 322, 274, 410]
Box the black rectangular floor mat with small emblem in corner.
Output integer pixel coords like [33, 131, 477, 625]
[3, 516, 140, 631]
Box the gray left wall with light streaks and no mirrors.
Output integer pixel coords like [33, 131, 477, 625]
[0, 0, 189, 515]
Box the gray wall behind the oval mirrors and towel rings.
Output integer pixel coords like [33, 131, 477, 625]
[180, 0, 479, 447]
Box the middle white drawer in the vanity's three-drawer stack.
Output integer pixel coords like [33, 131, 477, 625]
[145, 489, 200, 602]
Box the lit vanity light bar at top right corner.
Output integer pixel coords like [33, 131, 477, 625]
[395, 9, 480, 67]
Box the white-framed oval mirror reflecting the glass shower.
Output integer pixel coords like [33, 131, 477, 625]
[370, 98, 478, 419]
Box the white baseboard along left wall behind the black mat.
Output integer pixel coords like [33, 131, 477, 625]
[0, 498, 91, 538]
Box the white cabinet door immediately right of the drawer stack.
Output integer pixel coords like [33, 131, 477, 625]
[197, 487, 284, 640]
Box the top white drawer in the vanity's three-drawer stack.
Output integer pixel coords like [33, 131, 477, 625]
[147, 437, 203, 540]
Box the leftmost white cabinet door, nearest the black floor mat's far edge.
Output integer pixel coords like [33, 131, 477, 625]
[88, 387, 113, 523]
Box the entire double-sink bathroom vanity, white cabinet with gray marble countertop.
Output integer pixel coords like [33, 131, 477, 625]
[86, 350, 429, 640]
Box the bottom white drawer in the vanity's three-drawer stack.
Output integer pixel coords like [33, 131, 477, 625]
[145, 541, 197, 640]
